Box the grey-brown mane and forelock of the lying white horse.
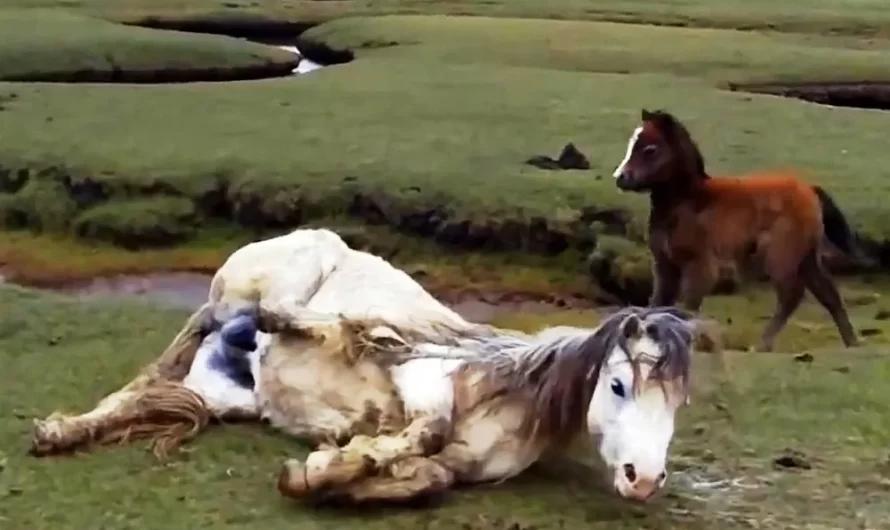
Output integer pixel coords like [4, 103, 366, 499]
[501, 307, 695, 441]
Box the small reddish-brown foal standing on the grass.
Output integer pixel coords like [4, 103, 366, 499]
[613, 109, 858, 351]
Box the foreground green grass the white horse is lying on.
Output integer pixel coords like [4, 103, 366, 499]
[0, 287, 890, 530]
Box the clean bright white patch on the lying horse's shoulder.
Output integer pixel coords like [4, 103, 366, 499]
[390, 358, 464, 419]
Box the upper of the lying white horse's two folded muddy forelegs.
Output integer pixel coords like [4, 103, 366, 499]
[278, 416, 451, 498]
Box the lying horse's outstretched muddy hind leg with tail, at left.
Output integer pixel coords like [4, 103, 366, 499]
[30, 305, 210, 456]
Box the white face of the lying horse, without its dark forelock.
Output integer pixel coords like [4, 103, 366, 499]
[587, 337, 682, 500]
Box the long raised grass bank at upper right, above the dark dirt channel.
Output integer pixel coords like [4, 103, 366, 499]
[304, 16, 890, 85]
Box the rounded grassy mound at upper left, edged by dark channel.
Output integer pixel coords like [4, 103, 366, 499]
[0, 9, 297, 83]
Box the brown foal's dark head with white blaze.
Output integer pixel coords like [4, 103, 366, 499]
[612, 109, 708, 192]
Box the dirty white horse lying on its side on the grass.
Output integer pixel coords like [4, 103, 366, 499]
[32, 229, 716, 502]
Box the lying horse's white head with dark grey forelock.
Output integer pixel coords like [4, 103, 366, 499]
[587, 308, 695, 501]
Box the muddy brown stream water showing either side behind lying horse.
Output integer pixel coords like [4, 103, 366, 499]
[10, 270, 589, 323]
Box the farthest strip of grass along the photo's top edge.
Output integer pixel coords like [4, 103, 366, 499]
[4, 0, 890, 36]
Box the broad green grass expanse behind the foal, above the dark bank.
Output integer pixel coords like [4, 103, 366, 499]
[0, 12, 890, 254]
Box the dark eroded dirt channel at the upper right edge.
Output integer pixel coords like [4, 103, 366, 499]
[730, 81, 890, 110]
